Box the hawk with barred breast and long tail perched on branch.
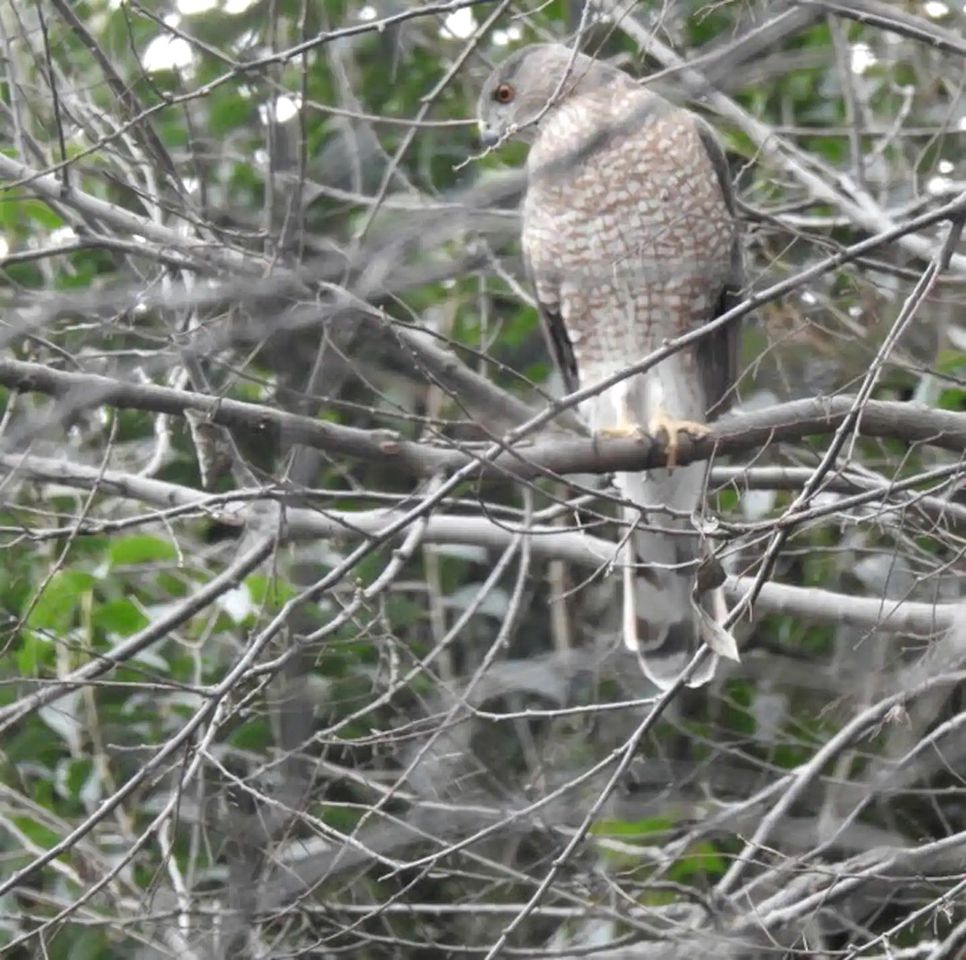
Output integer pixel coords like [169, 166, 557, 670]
[479, 44, 744, 687]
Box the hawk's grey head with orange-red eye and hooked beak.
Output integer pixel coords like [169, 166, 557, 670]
[477, 43, 613, 147]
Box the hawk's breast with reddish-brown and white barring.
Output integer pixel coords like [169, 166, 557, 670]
[523, 99, 735, 367]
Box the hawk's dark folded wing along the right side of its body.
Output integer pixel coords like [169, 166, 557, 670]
[695, 117, 745, 417]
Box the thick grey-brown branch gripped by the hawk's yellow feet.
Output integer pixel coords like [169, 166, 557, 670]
[0, 360, 966, 479]
